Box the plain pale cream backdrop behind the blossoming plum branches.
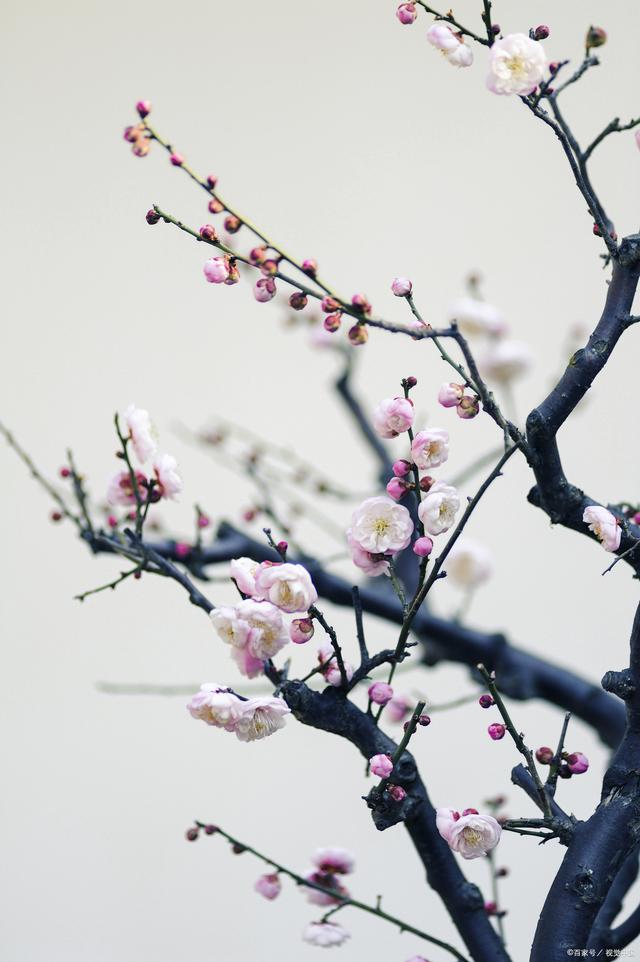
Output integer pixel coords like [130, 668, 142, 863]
[0, 0, 640, 962]
